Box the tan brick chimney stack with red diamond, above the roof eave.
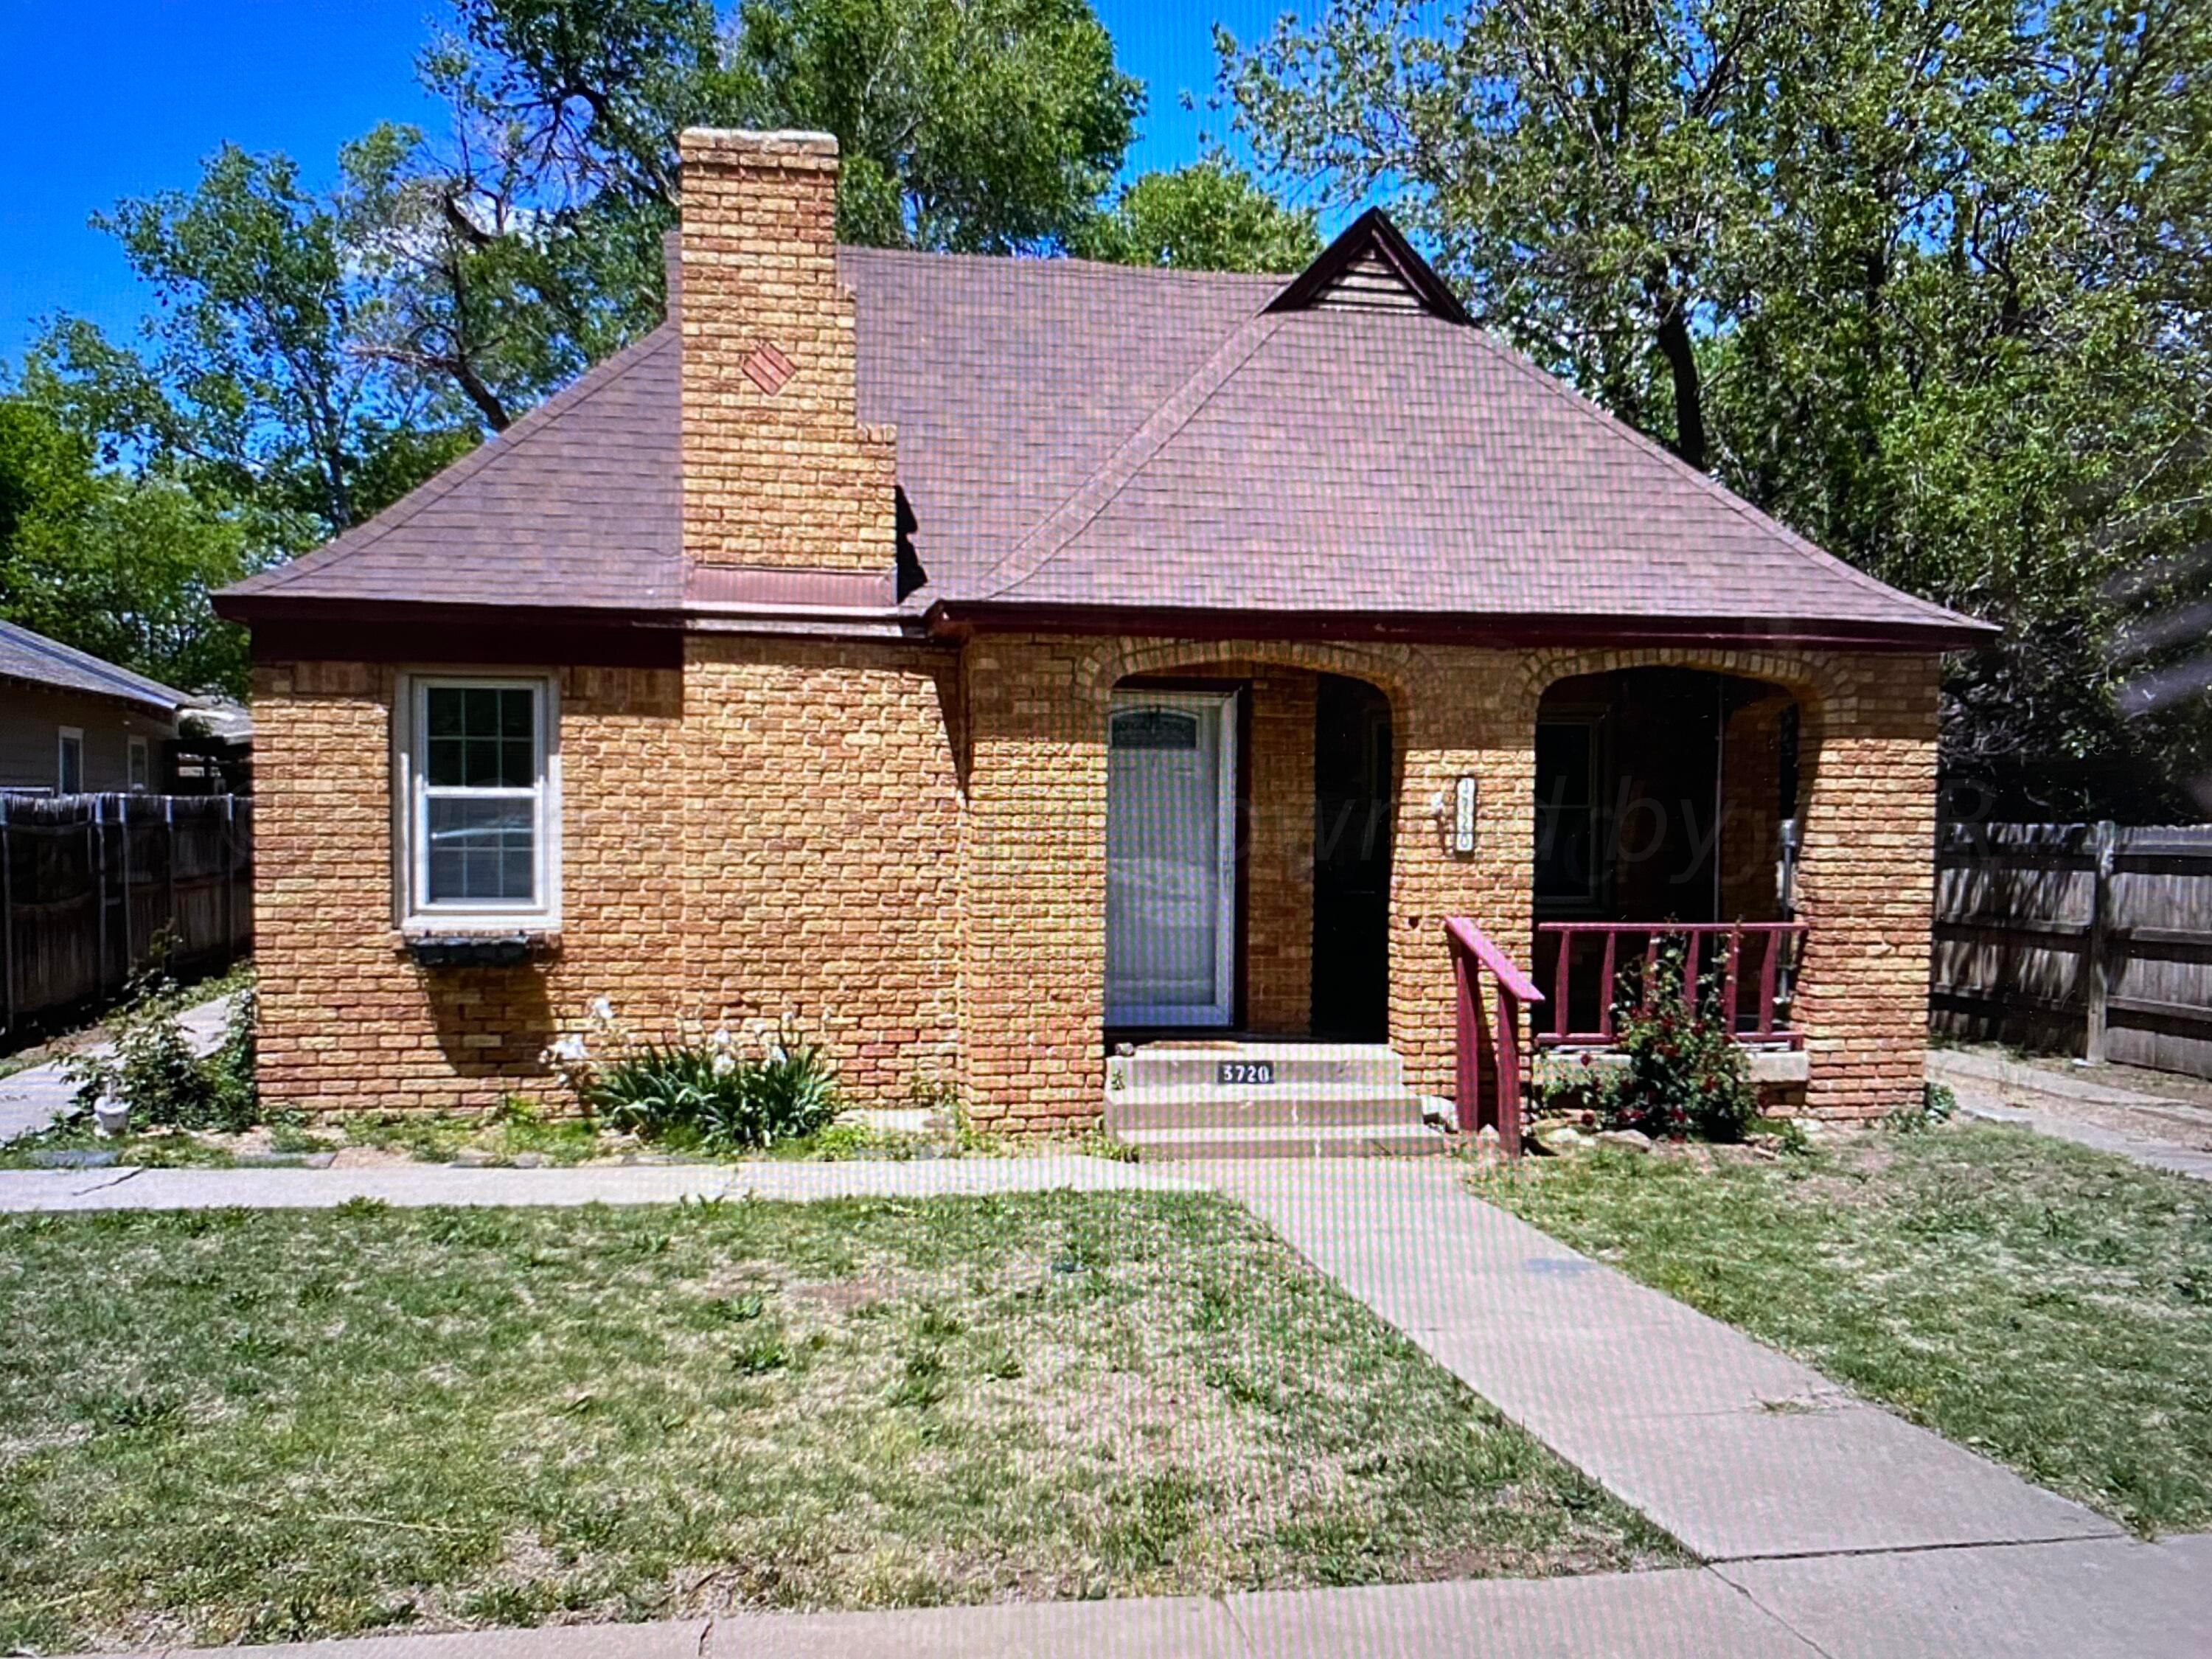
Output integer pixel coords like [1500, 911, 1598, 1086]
[672, 126, 896, 580]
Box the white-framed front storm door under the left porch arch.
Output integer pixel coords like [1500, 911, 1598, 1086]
[1106, 690, 1237, 1026]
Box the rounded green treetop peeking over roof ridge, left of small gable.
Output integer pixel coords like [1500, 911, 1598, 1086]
[1068, 157, 1321, 272]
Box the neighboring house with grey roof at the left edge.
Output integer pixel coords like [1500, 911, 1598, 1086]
[0, 622, 192, 794]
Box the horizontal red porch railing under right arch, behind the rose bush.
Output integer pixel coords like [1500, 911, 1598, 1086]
[1535, 922, 1805, 1048]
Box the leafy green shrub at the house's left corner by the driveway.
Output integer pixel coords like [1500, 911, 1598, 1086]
[69, 973, 261, 1130]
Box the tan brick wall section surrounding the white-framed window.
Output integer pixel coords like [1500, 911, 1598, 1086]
[254, 664, 681, 1110]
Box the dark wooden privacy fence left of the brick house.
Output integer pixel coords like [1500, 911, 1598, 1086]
[0, 792, 254, 1037]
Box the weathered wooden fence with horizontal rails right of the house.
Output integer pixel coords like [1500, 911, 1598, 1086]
[1929, 823, 2212, 1077]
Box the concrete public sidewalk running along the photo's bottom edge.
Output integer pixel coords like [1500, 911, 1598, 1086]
[69, 1537, 2212, 1659]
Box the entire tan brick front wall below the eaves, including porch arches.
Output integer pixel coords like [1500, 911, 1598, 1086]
[254, 635, 1935, 1128]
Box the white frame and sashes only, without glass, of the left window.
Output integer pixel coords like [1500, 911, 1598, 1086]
[392, 668, 560, 933]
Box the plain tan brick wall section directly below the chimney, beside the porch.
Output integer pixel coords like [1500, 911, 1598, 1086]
[681, 635, 960, 1104]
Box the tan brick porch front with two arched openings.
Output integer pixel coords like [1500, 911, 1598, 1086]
[962, 635, 1935, 1124]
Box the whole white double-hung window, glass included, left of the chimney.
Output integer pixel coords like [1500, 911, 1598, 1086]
[403, 677, 560, 929]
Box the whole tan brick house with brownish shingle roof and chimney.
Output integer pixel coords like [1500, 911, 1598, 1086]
[219, 131, 1989, 1126]
